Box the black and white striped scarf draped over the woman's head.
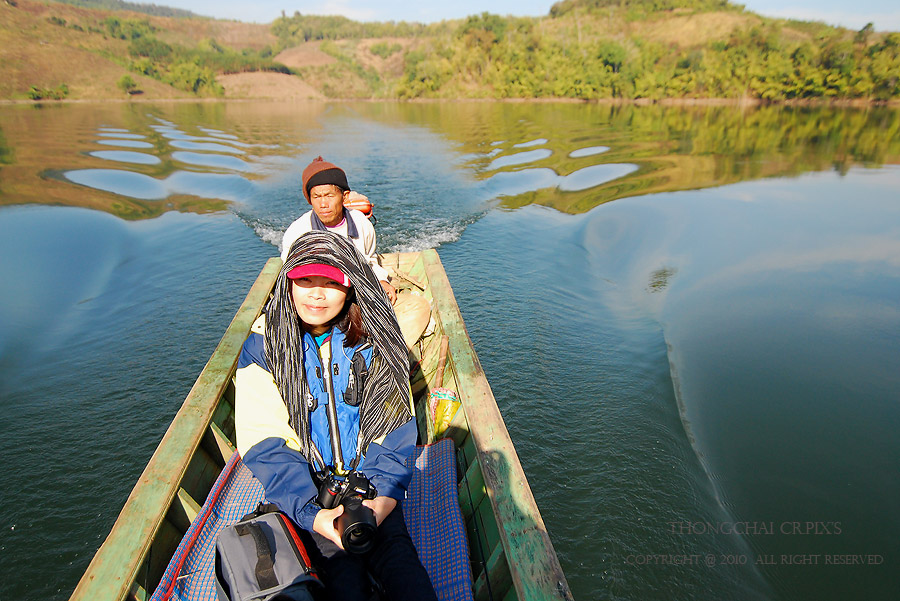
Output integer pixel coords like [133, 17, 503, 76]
[265, 231, 413, 463]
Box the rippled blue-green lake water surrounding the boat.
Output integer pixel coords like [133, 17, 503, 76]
[0, 103, 900, 601]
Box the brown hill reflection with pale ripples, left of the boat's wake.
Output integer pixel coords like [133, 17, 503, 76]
[0, 103, 322, 219]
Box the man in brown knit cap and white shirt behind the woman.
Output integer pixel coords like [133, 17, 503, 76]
[281, 157, 397, 304]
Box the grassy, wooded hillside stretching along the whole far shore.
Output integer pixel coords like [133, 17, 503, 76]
[0, 0, 900, 102]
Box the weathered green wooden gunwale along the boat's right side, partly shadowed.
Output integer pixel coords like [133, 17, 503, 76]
[422, 250, 572, 601]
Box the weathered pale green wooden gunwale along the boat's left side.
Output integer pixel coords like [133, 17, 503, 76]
[71, 258, 281, 601]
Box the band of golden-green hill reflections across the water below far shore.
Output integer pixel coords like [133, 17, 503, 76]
[0, 103, 900, 219]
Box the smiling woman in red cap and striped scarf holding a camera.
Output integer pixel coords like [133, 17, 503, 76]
[235, 232, 436, 600]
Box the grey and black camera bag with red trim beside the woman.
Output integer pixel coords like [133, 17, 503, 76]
[216, 503, 322, 601]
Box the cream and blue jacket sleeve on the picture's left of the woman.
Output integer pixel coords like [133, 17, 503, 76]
[234, 324, 319, 531]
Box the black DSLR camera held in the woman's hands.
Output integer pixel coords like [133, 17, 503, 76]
[316, 472, 378, 553]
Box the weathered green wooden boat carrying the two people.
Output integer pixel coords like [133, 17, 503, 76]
[71, 250, 572, 601]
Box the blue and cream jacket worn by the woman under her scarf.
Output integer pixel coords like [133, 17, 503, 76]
[235, 317, 417, 531]
